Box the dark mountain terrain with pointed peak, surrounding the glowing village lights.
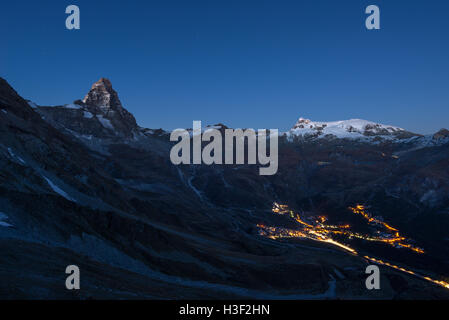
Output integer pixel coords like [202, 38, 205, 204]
[0, 78, 449, 299]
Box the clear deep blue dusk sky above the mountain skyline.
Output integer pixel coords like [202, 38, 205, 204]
[0, 0, 449, 133]
